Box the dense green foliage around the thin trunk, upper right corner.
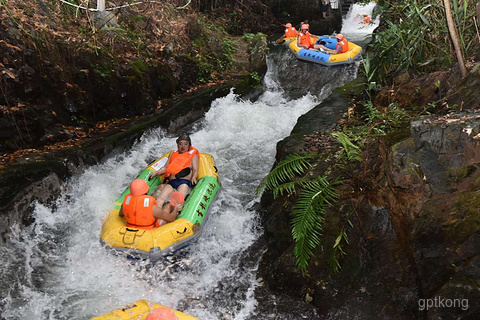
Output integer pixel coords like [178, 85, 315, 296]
[369, 0, 479, 83]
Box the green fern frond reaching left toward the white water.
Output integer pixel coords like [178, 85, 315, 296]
[256, 153, 316, 195]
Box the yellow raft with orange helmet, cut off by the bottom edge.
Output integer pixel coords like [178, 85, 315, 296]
[91, 300, 199, 320]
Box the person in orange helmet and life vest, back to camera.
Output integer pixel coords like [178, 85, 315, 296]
[119, 179, 181, 229]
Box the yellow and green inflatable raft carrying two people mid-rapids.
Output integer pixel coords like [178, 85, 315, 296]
[101, 151, 220, 261]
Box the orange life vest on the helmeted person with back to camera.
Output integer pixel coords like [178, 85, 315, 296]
[122, 194, 160, 229]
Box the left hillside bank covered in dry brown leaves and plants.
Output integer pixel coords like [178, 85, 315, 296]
[0, 0, 266, 154]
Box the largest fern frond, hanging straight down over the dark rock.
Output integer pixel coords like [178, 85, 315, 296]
[291, 177, 339, 272]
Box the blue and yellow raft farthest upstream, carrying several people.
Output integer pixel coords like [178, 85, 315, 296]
[289, 36, 362, 66]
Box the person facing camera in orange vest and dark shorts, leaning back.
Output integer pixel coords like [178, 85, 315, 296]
[150, 135, 200, 208]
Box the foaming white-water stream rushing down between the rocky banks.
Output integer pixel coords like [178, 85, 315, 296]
[0, 2, 378, 320]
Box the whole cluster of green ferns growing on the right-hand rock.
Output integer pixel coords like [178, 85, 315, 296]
[257, 132, 362, 273]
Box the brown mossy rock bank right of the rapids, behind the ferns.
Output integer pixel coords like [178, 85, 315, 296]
[259, 64, 480, 319]
